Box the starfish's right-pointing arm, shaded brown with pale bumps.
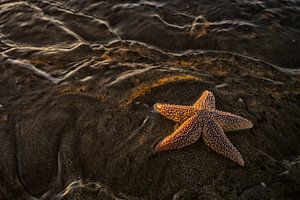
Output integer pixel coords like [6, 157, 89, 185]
[213, 110, 253, 131]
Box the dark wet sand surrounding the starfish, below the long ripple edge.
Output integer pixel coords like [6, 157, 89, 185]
[0, 43, 300, 199]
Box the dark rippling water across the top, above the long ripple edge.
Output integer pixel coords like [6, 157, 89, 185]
[0, 0, 300, 68]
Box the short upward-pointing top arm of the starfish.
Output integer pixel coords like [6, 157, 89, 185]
[193, 90, 216, 110]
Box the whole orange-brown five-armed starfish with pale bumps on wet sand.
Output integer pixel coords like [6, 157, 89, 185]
[154, 90, 253, 167]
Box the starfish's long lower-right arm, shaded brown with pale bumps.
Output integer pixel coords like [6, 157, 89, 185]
[202, 119, 245, 167]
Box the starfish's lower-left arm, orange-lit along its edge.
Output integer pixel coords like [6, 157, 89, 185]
[155, 115, 203, 152]
